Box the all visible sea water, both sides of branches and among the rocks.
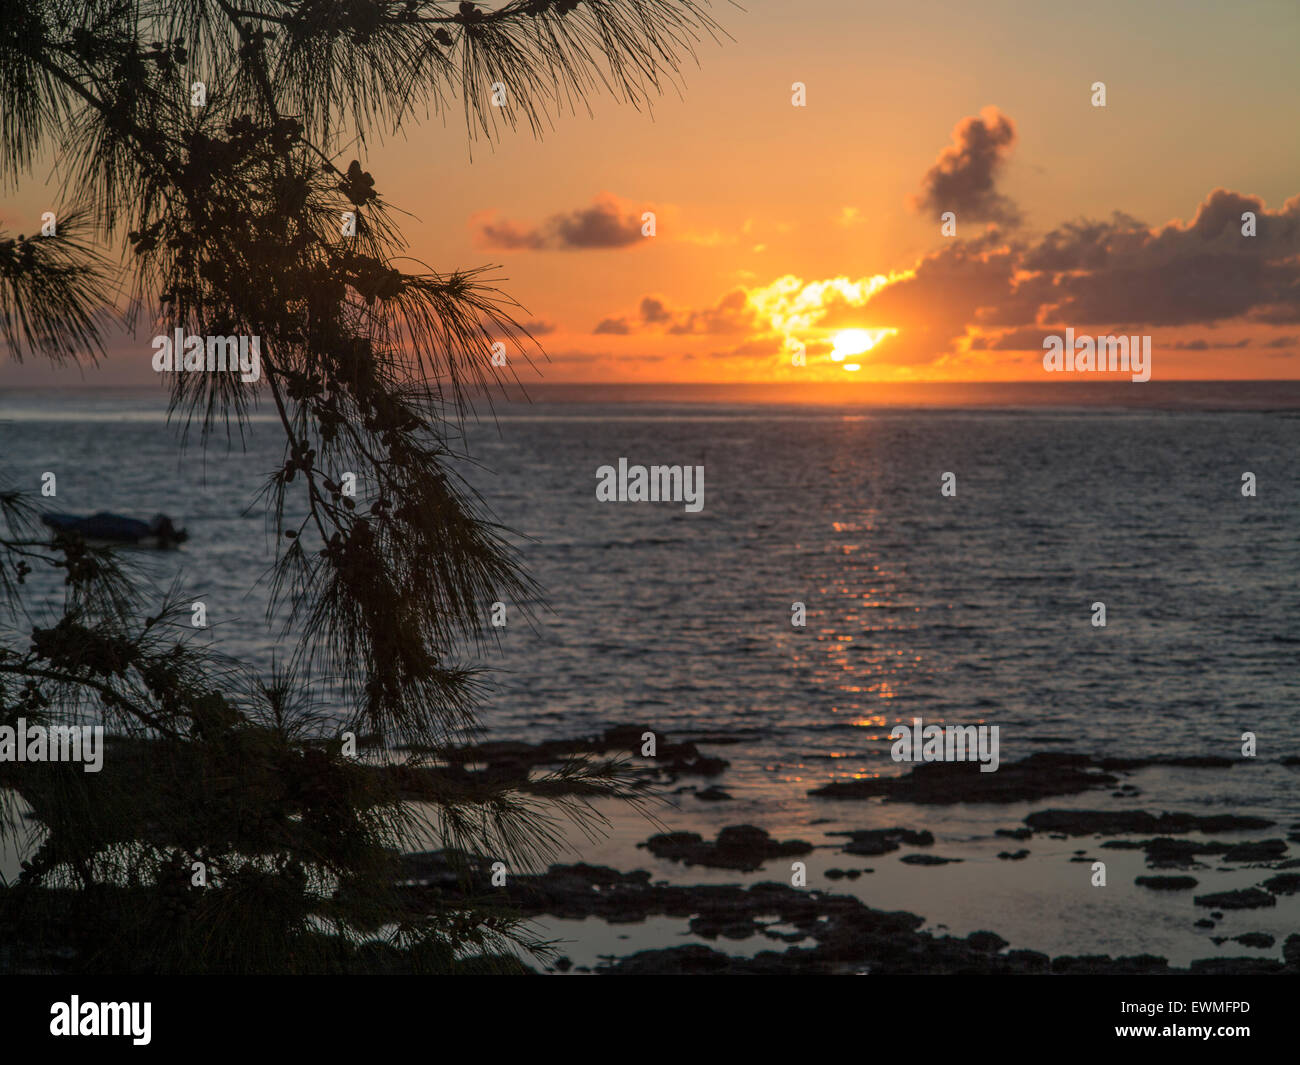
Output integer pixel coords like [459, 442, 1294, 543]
[0, 391, 1300, 962]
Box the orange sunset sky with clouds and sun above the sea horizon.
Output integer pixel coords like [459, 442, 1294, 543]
[0, 0, 1300, 385]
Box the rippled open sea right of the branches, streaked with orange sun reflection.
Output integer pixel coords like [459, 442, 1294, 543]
[478, 408, 1300, 785]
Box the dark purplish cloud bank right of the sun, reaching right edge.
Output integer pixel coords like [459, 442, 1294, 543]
[868, 189, 1300, 364]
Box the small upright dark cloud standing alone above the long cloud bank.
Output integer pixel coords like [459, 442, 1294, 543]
[913, 107, 1021, 226]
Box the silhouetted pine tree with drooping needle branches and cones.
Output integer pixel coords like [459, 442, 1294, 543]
[0, 0, 715, 971]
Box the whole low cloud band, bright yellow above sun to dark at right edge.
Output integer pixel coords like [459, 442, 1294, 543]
[582, 189, 1300, 367]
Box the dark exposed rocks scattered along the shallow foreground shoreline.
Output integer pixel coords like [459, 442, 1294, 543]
[387, 726, 1300, 975]
